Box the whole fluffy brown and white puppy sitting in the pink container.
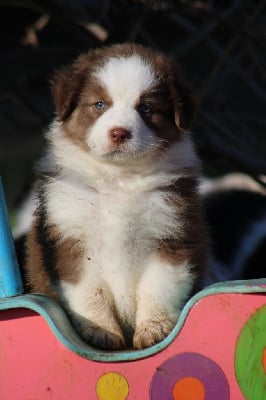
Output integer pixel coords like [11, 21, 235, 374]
[23, 44, 205, 350]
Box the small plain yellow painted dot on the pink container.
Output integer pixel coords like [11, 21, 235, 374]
[96, 372, 128, 400]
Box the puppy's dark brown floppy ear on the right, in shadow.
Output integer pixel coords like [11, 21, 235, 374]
[170, 64, 198, 132]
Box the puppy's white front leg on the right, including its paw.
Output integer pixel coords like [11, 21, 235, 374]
[133, 258, 193, 349]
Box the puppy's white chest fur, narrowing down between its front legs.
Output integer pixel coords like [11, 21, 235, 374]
[46, 172, 179, 319]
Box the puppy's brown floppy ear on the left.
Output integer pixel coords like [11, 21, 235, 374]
[51, 56, 87, 121]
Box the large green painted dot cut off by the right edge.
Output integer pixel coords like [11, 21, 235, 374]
[235, 305, 266, 400]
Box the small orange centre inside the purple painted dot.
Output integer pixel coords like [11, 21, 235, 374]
[173, 376, 205, 400]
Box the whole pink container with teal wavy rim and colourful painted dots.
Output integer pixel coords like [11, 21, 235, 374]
[0, 280, 266, 400]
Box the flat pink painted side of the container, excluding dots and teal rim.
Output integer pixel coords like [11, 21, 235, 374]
[0, 294, 266, 400]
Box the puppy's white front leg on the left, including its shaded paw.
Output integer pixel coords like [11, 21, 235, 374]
[61, 279, 125, 350]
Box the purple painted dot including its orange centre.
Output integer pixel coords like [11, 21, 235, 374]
[150, 353, 230, 400]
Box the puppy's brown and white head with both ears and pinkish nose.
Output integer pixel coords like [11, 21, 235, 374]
[52, 44, 195, 162]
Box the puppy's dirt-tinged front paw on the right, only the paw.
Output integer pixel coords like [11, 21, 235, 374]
[133, 318, 175, 350]
